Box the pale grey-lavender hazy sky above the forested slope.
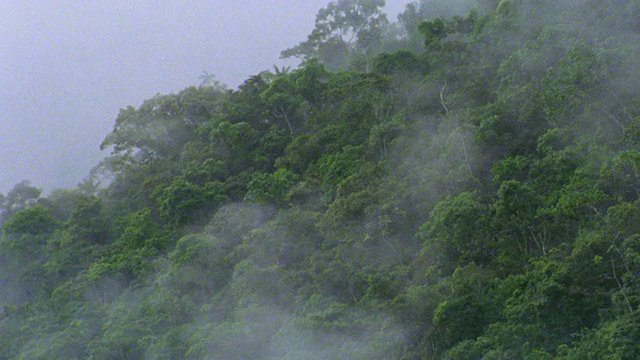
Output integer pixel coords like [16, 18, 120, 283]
[0, 0, 411, 193]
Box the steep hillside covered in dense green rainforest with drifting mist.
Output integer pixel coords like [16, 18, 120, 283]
[0, 0, 640, 360]
